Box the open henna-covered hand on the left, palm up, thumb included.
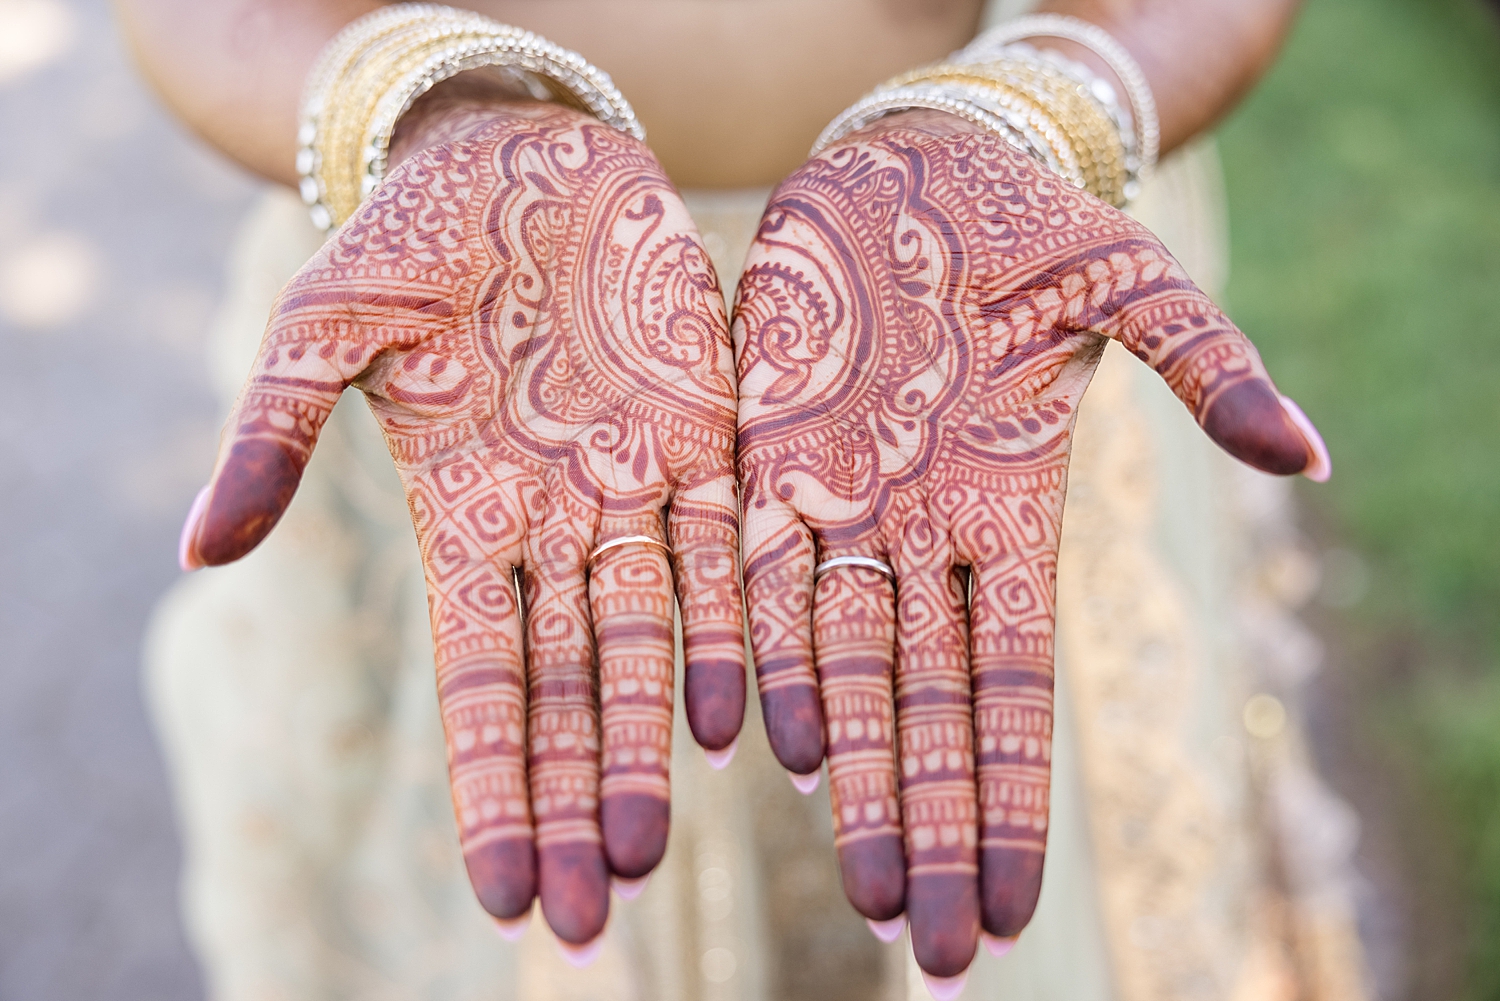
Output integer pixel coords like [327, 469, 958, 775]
[185, 105, 744, 944]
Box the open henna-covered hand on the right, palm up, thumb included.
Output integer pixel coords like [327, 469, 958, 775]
[735, 113, 1326, 977]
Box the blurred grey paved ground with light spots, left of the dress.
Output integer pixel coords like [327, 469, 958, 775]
[0, 0, 254, 1001]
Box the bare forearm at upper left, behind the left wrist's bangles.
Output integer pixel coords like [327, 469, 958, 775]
[114, 0, 372, 185]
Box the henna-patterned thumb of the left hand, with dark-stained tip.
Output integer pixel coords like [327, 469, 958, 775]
[177, 287, 369, 570]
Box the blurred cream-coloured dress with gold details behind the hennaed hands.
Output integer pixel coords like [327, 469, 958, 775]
[146, 3, 1359, 1001]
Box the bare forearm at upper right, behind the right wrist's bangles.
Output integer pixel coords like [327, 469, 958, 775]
[1041, 0, 1301, 153]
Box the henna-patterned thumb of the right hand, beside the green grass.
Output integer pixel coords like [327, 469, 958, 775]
[1088, 239, 1332, 483]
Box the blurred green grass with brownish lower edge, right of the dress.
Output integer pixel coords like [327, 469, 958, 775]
[1221, 0, 1500, 1001]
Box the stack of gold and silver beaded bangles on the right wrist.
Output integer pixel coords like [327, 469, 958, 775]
[813, 14, 1160, 206]
